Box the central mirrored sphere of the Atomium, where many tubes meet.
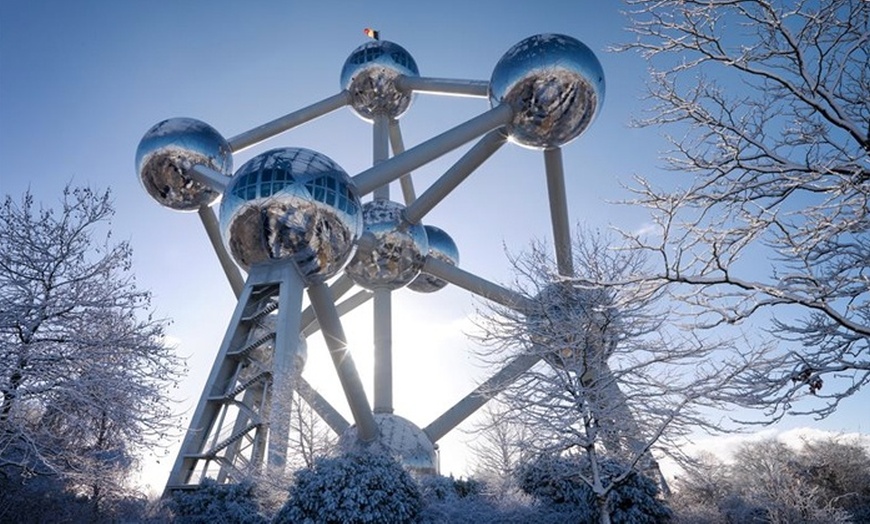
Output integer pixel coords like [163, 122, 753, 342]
[345, 199, 429, 290]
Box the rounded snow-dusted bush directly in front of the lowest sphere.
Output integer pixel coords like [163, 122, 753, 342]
[274, 453, 423, 524]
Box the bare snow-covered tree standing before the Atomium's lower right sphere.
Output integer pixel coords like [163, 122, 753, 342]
[470, 229, 742, 522]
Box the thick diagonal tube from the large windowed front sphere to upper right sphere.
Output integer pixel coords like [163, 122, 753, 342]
[353, 104, 513, 195]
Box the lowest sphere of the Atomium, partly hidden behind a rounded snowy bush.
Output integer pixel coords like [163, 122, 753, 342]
[338, 413, 438, 475]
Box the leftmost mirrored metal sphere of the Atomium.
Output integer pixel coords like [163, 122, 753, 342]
[136, 118, 233, 211]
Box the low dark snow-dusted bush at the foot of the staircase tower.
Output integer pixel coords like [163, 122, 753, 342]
[168, 479, 267, 524]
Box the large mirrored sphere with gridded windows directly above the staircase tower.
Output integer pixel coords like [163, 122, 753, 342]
[220, 147, 362, 283]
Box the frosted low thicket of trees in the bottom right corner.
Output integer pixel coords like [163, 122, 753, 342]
[673, 439, 870, 524]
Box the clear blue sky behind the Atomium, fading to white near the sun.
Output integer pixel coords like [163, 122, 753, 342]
[0, 0, 870, 489]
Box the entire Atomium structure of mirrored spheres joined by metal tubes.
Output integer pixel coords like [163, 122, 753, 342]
[136, 34, 632, 492]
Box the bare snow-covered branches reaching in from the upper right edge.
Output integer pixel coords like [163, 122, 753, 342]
[620, 0, 870, 421]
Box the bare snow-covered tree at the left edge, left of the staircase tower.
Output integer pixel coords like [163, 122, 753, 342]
[0, 188, 181, 512]
